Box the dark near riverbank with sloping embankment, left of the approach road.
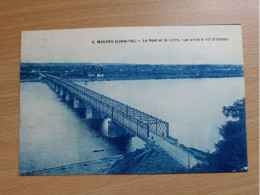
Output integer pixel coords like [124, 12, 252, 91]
[21, 147, 188, 175]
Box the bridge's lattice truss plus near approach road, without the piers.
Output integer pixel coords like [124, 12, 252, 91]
[41, 74, 201, 168]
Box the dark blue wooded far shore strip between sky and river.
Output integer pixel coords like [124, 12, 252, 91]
[20, 63, 244, 80]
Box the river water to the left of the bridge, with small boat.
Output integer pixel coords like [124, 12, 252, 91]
[19, 83, 144, 173]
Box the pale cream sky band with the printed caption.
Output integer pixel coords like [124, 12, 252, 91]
[21, 25, 243, 65]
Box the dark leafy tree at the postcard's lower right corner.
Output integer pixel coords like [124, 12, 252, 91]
[193, 98, 247, 172]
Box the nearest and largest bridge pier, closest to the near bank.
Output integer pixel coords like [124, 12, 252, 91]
[108, 120, 132, 138]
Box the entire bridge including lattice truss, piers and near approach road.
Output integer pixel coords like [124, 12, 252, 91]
[40, 73, 201, 168]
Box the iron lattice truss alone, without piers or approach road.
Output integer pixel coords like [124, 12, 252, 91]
[42, 75, 169, 140]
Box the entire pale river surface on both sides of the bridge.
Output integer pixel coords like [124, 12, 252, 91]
[19, 78, 245, 173]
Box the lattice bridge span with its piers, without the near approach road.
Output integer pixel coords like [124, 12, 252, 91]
[44, 75, 169, 142]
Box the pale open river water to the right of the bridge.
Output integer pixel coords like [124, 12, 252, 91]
[76, 78, 245, 151]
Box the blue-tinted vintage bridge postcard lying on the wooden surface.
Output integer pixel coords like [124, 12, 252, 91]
[19, 25, 248, 175]
